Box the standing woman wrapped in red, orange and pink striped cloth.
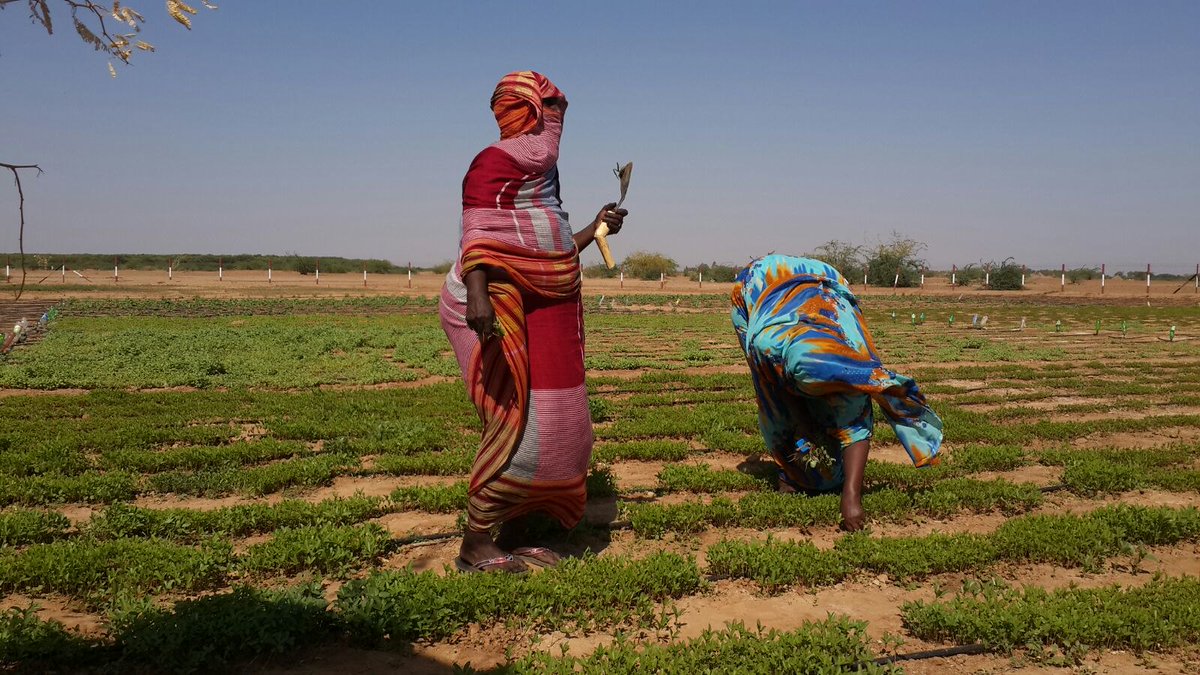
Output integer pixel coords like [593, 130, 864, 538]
[440, 71, 628, 572]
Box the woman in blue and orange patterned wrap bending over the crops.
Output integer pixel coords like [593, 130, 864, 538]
[732, 255, 942, 531]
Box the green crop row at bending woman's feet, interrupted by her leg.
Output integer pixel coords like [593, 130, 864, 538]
[624, 478, 1042, 538]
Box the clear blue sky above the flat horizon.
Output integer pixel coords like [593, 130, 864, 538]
[0, 0, 1200, 271]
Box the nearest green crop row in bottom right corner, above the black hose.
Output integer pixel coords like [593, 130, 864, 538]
[902, 578, 1200, 652]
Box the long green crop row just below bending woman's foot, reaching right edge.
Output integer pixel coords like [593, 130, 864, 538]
[707, 506, 1200, 592]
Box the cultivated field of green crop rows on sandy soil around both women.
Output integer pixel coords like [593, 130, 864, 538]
[0, 273, 1200, 673]
